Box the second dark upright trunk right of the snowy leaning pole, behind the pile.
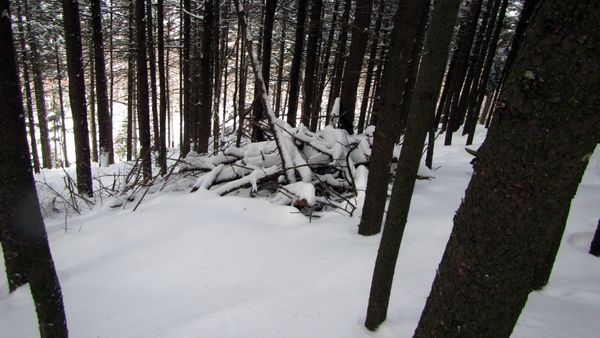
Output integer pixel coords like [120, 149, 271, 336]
[287, 0, 308, 127]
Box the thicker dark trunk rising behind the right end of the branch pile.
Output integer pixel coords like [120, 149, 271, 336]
[340, 0, 373, 134]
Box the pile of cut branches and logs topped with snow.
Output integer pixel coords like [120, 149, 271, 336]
[178, 125, 372, 214]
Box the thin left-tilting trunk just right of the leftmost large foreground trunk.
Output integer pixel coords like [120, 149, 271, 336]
[15, 2, 40, 173]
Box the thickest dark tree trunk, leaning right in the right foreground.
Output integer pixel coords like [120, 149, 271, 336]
[415, 0, 600, 337]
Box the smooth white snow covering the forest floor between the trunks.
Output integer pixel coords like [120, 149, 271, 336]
[0, 133, 600, 338]
